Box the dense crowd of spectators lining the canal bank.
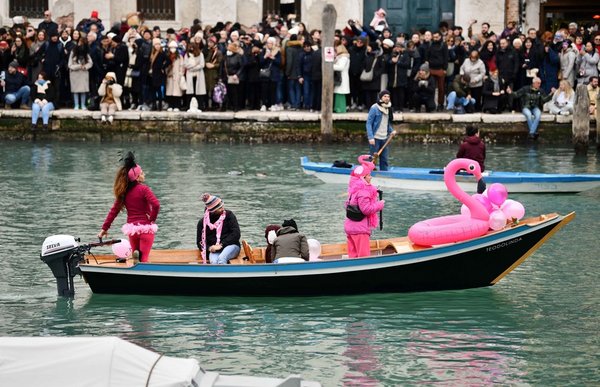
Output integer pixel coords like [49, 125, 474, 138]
[0, 9, 600, 121]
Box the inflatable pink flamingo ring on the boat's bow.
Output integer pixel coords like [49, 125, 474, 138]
[408, 159, 490, 246]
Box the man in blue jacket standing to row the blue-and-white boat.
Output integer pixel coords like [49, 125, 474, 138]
[367, 90, 396, 171]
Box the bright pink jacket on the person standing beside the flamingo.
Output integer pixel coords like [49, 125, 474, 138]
[344, 176, 384, 235]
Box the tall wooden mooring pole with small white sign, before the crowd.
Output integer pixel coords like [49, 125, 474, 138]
[321, 4, 337, 142]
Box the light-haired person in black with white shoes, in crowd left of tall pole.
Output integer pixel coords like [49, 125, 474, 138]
[259, 36, 283, 111]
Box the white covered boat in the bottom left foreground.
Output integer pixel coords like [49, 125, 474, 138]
[0, 337, 321, 387]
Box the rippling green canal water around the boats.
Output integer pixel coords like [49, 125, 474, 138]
[0, 142, 600, 386]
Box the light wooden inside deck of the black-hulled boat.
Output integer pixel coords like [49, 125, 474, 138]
[85, 213, 558, 267]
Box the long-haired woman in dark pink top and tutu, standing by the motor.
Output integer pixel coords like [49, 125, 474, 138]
[98, 152, 160, 262]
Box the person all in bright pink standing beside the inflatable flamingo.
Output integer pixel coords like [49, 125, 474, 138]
[344, 155, 385, 258]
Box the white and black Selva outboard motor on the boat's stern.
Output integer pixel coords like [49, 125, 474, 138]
[40, 235, 83, 297]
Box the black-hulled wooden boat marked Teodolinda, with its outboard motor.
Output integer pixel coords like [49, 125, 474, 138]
[41, 213, 575, 296]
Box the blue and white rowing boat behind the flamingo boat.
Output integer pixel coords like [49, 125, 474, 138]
[301, 156, 600, 193]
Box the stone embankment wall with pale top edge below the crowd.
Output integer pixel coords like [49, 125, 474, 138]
[0, 109, 596, 145]
